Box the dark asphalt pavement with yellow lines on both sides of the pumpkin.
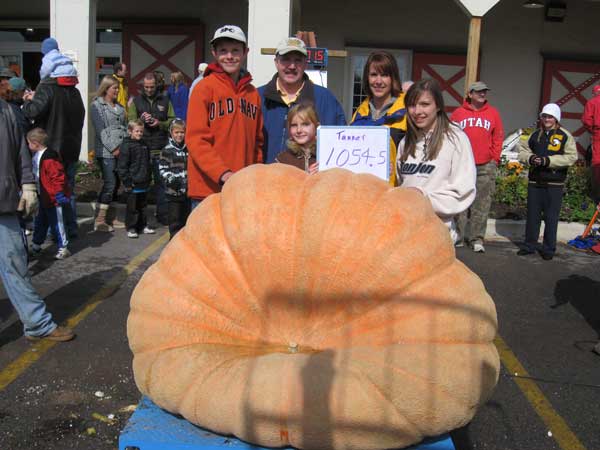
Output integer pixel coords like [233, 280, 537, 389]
[0, 211, 600, 450]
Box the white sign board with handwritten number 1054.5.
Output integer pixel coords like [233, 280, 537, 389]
[317, 126, 390, 181]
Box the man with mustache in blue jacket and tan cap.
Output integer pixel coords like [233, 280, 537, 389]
[258, 37, 346, 163]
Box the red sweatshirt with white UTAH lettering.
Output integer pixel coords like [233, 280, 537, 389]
[450, 101, 504, 165]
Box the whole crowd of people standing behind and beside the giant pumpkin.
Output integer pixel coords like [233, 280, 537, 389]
[0, 25, 600, 341]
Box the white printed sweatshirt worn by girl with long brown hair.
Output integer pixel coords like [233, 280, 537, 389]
[396, 125, 477, 230]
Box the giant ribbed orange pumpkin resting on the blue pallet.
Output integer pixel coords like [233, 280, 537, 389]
[128, 164, 499, 450]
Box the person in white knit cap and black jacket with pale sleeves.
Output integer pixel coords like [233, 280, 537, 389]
[517, 103, 577, 260]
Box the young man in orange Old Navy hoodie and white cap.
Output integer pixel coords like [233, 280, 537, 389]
[185, 25, 263, 207]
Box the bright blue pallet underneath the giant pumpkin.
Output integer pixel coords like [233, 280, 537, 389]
[119, 397, 455, 450]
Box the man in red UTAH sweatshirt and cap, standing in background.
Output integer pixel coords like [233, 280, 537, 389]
[450, 81, 504, 253]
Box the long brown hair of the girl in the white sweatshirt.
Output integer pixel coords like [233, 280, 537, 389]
[402, 79, 454, 161]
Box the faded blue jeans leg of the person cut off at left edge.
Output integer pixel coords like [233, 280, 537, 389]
[0, 214, 56, 337]
